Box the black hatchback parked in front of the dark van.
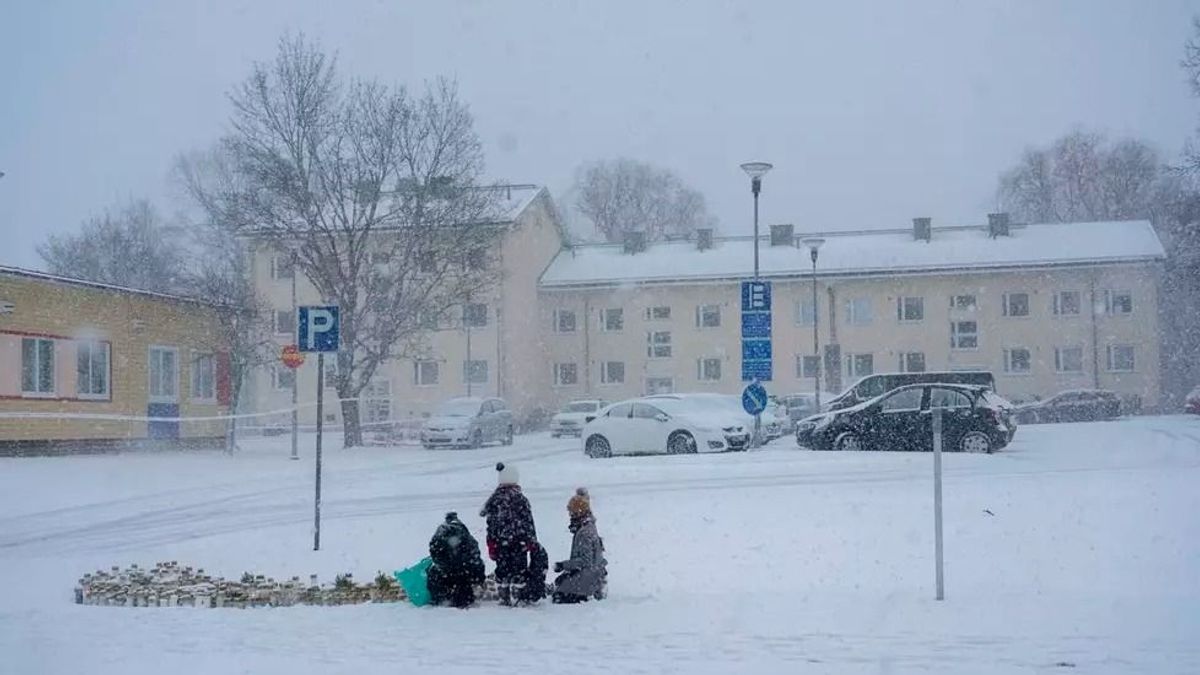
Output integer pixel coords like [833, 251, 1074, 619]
[796, 383, 1016, 453]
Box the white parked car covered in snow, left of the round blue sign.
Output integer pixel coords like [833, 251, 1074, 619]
[583, 394, 750, 458]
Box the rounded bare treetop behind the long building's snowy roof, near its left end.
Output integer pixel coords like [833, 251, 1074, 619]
[574, 157, 715, 241]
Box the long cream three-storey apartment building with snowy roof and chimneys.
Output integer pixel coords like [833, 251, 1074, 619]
[539, 217, 1164, 406]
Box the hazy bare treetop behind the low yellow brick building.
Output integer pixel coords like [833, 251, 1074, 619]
[37, 199, 187, 293]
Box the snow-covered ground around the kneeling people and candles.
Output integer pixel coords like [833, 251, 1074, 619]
[0, 417, 1200, 675]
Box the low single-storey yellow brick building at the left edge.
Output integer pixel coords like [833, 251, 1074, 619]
[0, 267, 229, 453]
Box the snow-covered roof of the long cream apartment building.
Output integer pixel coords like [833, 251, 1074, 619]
[540, 220, 1165, 288]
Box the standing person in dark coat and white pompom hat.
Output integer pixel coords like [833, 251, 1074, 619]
[479, 462, 538, 604]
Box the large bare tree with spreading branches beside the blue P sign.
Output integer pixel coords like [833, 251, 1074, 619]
[185, 36, 504, 447]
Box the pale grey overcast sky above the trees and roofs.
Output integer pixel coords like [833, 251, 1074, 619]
[0, 0, 1200, 267]
